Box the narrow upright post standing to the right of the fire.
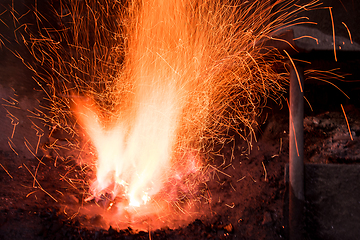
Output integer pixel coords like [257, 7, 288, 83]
[289, 62, 305, 240]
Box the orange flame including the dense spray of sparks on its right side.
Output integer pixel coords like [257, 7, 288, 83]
[69, 0, 310, 222]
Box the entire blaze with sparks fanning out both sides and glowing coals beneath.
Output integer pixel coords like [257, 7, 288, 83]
[4, 0, 317, 230]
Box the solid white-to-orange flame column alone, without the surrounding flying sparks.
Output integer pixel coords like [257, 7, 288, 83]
[75, 0, 208, 214]
